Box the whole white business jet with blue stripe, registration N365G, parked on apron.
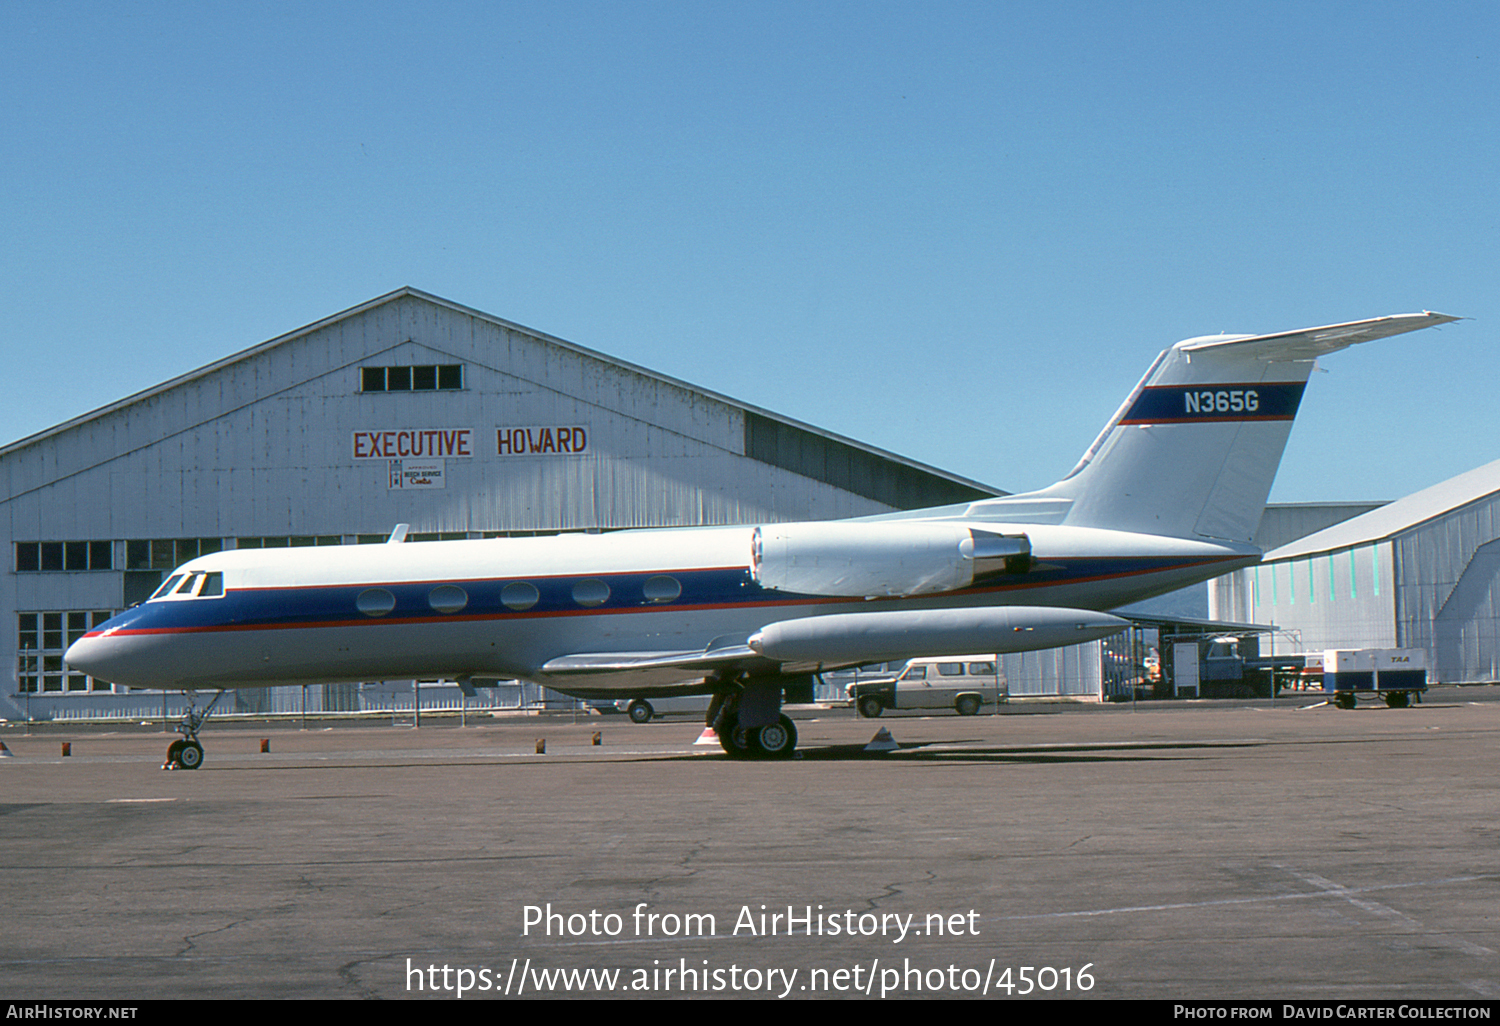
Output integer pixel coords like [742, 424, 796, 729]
[66, 312, 1458, 768]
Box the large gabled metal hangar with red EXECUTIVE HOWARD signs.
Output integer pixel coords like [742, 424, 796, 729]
[0, 288, 1002, 719]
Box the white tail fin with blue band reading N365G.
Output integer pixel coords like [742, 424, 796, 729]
[968, 312, 1460, 542]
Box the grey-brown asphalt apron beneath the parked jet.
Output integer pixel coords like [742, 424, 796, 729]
[0, 689, 1500, 1002]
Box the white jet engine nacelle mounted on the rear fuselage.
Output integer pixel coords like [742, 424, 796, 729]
[750, 521, 1031, 599]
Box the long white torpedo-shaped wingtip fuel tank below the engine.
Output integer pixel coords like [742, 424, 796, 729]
[749, 606, 1130, 666]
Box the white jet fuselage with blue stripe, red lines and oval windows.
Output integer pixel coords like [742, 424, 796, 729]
[68, 524, 1260, 695]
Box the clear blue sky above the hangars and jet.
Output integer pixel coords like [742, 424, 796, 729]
[0, 0, 1500, 501]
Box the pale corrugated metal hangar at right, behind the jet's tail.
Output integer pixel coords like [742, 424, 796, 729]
[1209, 462, 1500, 684]
